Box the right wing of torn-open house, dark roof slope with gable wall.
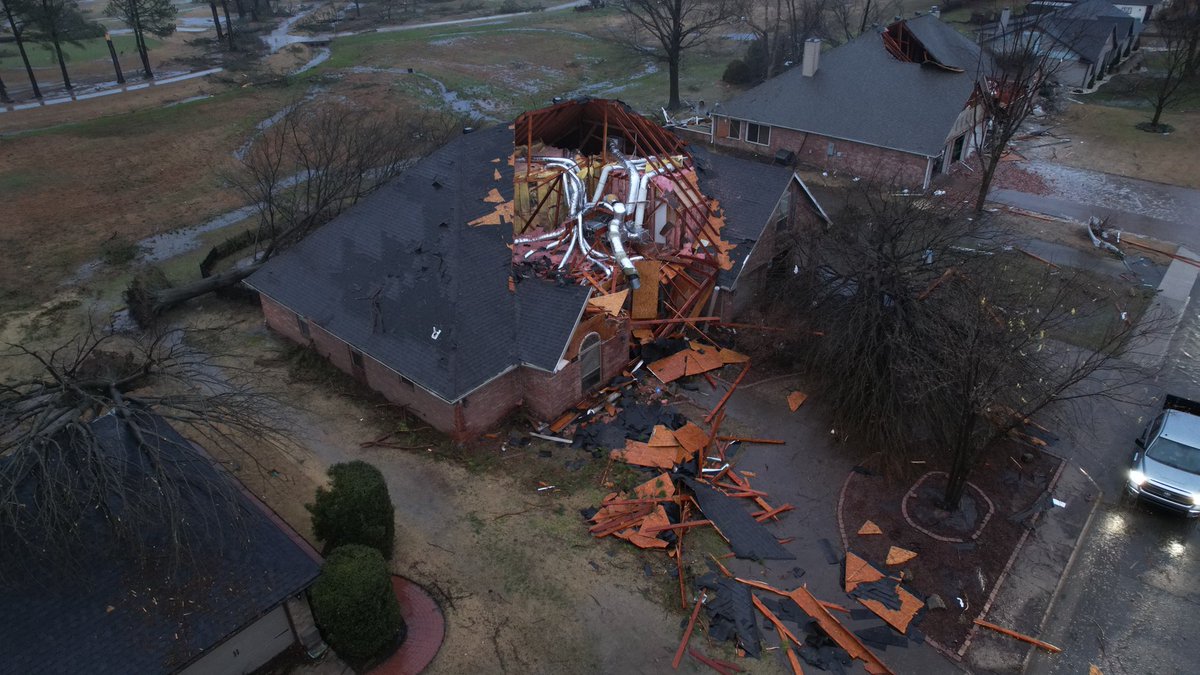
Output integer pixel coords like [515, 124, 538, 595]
[692, 148, 829, 321]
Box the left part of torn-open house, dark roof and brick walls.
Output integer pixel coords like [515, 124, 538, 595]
[247, 126, 629, 437]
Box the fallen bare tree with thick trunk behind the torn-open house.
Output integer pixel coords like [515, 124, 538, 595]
[125, 101, 457, 325]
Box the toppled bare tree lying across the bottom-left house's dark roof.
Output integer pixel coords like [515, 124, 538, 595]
[0, 327, 292, 571]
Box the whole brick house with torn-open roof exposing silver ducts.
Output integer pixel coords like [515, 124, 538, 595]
[246, 100, 816, 438]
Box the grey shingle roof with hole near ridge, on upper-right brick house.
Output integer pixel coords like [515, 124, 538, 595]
[719, 16, 979, 156]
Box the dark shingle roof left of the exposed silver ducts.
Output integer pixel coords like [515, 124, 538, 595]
[247, 126, 589, 402]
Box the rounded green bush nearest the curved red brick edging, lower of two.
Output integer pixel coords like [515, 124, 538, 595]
[310, 544, 404, 665]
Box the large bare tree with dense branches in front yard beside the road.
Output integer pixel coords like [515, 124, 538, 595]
[768, 189, 1157, 508]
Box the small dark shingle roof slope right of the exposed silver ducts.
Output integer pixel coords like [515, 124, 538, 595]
[691, 145, 792, 288]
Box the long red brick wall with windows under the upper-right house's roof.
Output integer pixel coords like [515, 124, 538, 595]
[706, 118, 928, 189]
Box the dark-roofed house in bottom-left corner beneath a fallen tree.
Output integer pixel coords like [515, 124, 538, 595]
[0, 414, 322, 675]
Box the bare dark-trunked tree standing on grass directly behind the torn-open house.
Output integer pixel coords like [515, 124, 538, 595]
[620, 0, 733, 110]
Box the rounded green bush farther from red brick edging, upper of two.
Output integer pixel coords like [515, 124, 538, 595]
[306, 460, 396, 560]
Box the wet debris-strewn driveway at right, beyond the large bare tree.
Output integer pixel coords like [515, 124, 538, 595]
[989, 160, 1200, 250]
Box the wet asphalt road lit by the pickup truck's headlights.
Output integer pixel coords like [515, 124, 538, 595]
[1028, 278, 1200, 675]
